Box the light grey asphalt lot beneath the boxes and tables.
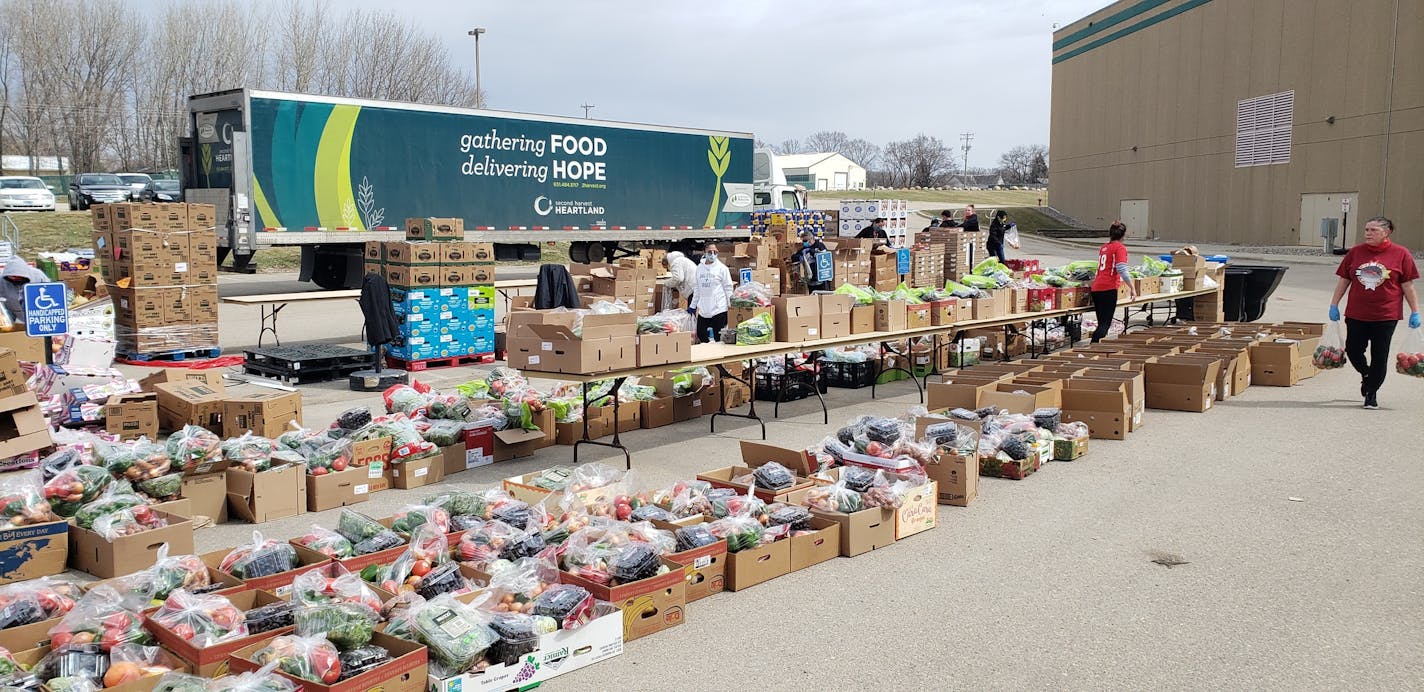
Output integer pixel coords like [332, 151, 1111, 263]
[111, 239, 1424, 691]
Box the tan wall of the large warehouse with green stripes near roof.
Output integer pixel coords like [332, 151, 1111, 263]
[1049, 0, 1424, 249]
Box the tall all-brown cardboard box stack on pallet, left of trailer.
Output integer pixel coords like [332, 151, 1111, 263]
[90, 204, 218, 353]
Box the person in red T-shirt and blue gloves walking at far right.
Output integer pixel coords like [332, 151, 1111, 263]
[1330, 216, 1420, 409]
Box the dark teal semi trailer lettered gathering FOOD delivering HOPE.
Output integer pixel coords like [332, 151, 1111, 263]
[179, 88, 803, 289]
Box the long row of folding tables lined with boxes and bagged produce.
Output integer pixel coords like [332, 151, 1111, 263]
[523, 289, 1220, 468]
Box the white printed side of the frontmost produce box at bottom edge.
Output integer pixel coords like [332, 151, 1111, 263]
[429, 604, 624, 692]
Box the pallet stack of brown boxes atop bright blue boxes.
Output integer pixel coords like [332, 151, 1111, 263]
[366, 218, 494, 360]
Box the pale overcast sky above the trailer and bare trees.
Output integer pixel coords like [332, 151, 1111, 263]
[332, 0, 1109, 167]
